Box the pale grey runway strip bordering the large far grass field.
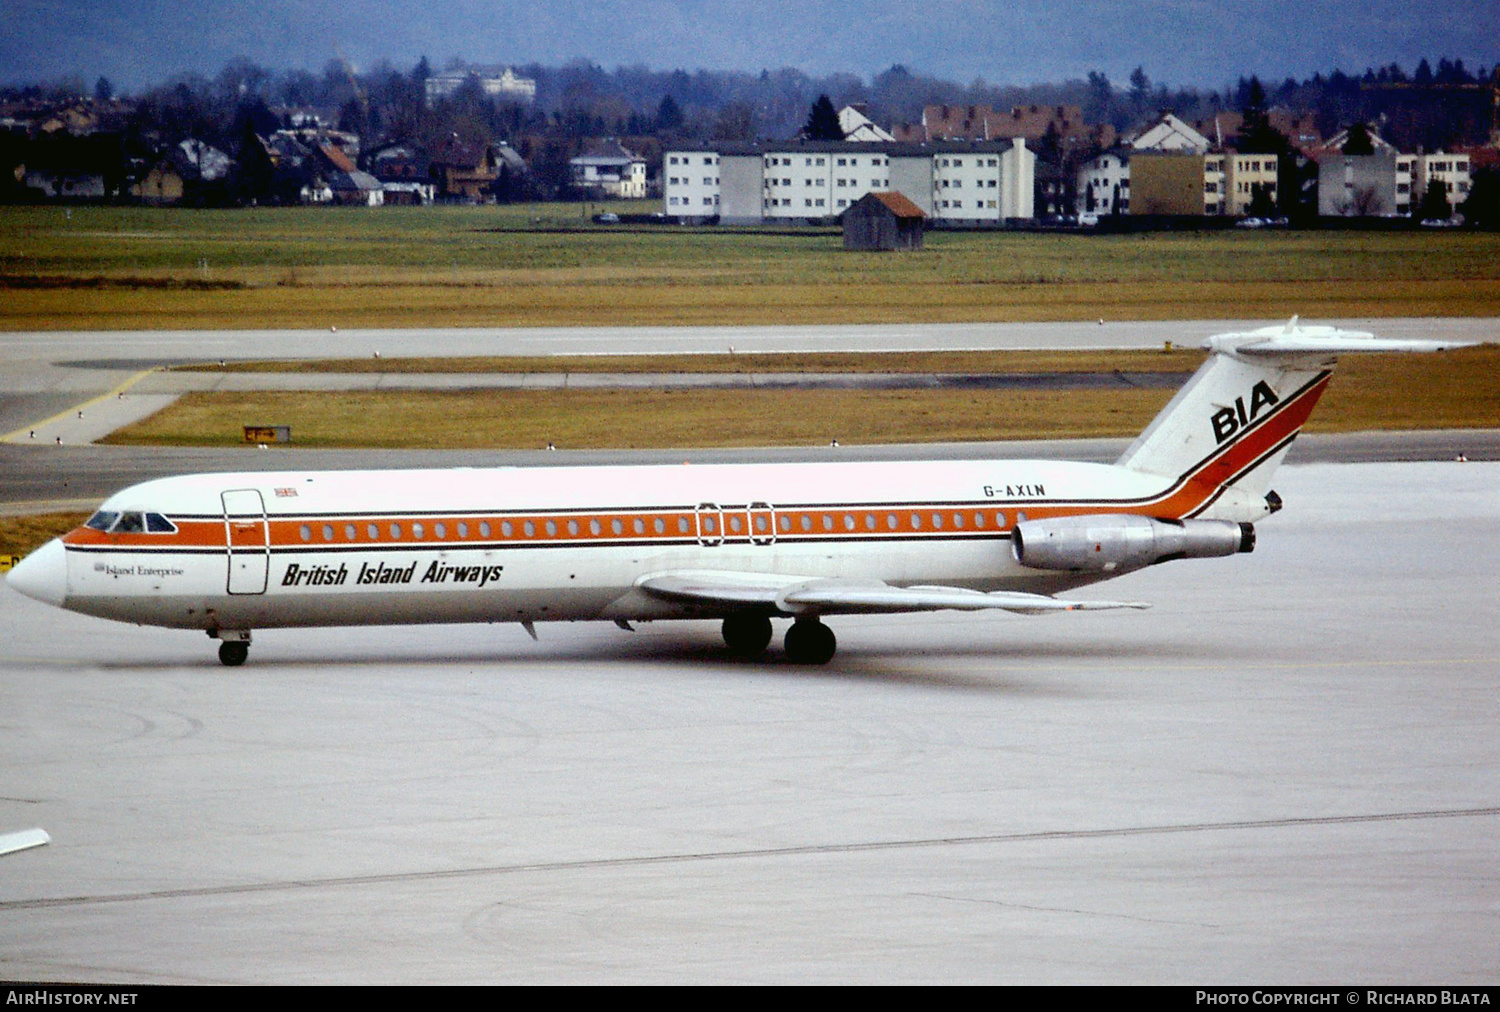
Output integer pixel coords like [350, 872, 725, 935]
[0, 318, 1500, 445]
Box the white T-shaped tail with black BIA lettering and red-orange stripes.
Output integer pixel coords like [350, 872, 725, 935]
[1116, 316, 1455, 520]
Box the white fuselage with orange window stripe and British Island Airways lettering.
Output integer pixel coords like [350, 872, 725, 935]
[49, 460, 1206, 631]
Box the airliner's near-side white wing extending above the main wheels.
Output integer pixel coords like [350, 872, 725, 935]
[636, 570, 1151, 616]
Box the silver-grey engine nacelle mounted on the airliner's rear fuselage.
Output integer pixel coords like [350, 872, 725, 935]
[1011, 513, 1256, 573]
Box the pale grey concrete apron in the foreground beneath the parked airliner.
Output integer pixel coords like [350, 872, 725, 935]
[0, 461, 1500, 985]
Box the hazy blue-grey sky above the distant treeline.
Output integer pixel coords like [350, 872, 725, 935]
[11, 0, 1500, 88]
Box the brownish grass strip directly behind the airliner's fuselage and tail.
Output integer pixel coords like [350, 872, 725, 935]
[107, 345, 1500, 448]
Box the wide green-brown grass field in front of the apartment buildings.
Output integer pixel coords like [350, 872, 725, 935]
[0, 205, 1500, 330]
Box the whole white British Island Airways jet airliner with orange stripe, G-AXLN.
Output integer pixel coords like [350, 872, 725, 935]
[8, 316, 1454, 666]
